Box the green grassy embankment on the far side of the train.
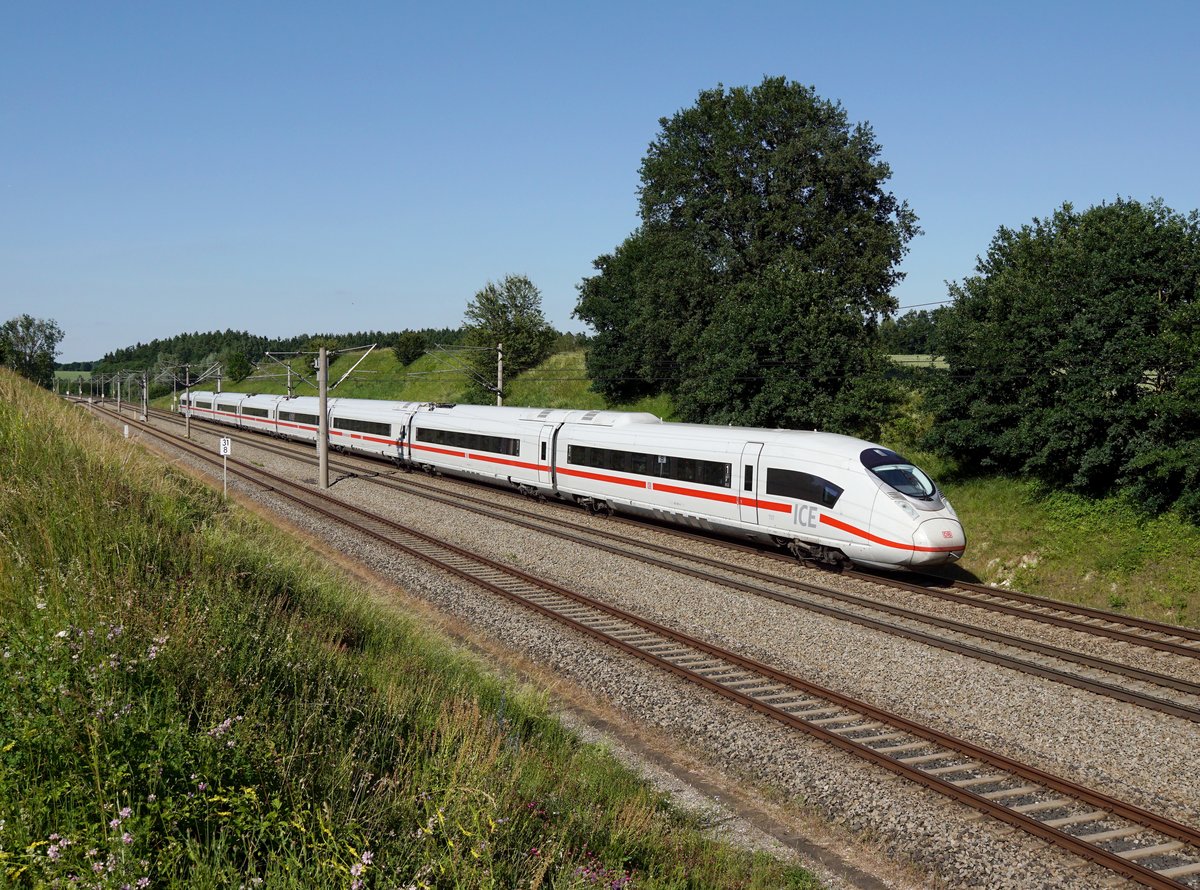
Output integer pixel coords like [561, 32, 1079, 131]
[184, 350, 1200, 626]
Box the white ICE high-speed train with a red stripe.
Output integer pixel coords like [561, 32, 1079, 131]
[180, 392, 966, 569]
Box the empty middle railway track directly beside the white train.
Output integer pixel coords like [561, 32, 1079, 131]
[131, 405, 1200, 722]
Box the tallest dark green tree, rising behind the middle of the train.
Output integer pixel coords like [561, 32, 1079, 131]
[576, 78, 918, 433]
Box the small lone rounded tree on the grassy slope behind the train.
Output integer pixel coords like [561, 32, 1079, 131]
[463, 275, 557, 395]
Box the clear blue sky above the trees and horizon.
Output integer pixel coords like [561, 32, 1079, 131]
[0, 0, 1200, 361]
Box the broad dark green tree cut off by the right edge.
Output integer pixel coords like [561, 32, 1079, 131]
[932, 200, 1200, 516]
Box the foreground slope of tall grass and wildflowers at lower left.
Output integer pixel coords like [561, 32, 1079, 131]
[0, 369, 810, 888]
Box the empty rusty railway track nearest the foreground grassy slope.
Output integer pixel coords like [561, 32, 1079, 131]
[88, 405, 1200, 888]
